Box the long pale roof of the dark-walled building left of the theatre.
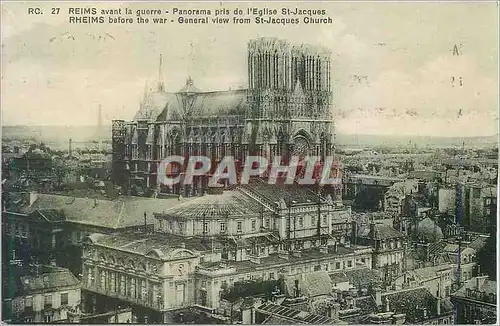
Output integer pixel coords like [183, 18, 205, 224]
[5, 194, 189, 229]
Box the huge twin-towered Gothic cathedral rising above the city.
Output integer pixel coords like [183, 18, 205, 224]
[112, 38, 339, 196]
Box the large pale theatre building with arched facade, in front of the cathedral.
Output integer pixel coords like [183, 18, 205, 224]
[78, 179, 372, 322]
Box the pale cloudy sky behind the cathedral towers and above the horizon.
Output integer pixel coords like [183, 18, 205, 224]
[1, 2, 499, 137]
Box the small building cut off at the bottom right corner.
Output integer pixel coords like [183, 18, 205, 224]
[451, 276, 498, 324]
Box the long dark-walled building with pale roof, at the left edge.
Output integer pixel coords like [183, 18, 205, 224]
[2, 192, 187, 275]
